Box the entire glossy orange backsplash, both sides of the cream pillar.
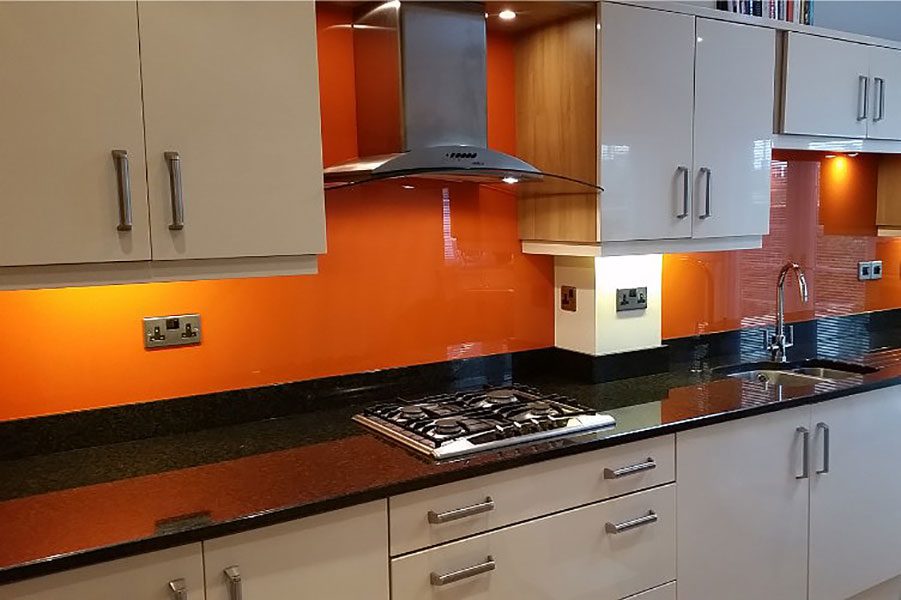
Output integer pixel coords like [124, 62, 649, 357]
[0, 5, 901, 420]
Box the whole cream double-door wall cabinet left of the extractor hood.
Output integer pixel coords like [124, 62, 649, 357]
[0, 2, 325, 288]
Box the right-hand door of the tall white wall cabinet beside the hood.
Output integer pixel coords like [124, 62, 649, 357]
[692, 19, 776, 238]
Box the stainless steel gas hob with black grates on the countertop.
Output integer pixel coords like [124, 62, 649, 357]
[354, 385, 616, 459]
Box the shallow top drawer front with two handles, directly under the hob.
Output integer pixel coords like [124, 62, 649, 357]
[389, 435, 675, 556]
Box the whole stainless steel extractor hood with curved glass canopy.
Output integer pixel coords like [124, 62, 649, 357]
[325, 0, 600, 193]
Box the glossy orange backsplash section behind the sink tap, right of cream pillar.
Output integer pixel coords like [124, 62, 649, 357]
[663, 151, 901, 338]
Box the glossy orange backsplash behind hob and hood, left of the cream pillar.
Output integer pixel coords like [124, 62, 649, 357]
[0, 7, 554, 420]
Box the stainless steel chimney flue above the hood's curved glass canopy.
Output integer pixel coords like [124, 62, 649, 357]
[353, 1, 488, 156]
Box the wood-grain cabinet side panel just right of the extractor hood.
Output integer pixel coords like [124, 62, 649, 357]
[516, 10, 598, 242]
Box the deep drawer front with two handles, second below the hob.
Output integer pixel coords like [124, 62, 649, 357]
[391, 485, 676, 600]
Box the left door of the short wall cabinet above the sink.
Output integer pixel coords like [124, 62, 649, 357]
[783, 32, 872, 138]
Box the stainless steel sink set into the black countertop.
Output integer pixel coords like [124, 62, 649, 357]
[717, 358, 878, 387]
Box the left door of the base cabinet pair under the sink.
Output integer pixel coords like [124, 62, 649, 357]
[676, 407, 810, 600]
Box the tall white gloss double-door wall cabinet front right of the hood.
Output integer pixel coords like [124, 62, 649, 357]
[600, 3, 776, 253]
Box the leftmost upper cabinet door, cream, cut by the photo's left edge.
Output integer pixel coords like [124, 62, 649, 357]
[0, 2, 150, 266]
